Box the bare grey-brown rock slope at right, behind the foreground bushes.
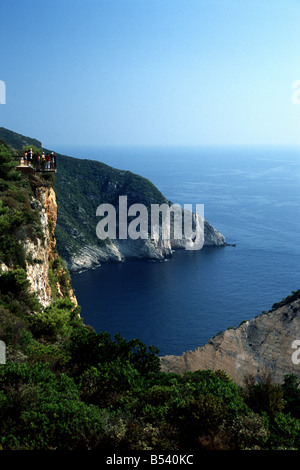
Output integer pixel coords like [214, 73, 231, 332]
[160, 300, 300, 385]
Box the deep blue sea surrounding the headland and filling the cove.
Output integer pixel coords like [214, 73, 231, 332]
[56, 146, 300, 355]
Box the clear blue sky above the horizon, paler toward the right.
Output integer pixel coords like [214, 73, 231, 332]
[0, 0, 300, 147]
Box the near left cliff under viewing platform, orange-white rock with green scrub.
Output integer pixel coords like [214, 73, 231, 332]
[0, 136, 77, 318]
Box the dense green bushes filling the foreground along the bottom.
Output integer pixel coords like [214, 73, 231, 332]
[0, 306, 300, 451]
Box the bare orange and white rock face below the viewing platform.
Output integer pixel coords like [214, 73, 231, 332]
[0, 179, 77, 307]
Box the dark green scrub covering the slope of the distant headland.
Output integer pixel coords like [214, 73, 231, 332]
[55, 155, 167, 260]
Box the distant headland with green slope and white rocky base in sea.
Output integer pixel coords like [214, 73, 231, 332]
[55, 155, 226, 272]
